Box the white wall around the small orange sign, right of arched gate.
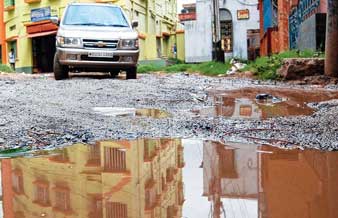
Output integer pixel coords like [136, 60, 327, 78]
[219, 0, 259, 59]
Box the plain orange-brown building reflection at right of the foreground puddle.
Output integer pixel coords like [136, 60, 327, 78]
[259, 147, 338, 218]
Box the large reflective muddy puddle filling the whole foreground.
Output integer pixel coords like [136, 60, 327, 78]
[0, 139, 338, 218]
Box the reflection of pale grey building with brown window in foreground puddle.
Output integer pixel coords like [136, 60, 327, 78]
[203, 141, 258, 218]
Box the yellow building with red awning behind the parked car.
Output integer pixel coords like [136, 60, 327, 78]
[0, 0, 184, 73]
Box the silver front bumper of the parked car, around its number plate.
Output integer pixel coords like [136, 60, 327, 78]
[56, 48, 139, 67]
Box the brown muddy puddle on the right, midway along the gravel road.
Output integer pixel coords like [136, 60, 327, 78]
[197, 88, 338, 119]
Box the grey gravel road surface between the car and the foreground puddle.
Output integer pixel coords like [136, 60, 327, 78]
[0, 73, 338, 150]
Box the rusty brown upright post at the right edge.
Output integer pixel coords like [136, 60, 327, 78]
[325, 0, 338, 77]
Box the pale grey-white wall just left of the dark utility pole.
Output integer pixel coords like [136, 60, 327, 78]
[184, 0, 212, 63]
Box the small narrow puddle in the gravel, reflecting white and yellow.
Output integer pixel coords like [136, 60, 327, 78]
[93, 107, 170, 119]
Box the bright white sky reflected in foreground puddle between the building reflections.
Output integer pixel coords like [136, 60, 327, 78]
[182, 139, 258, 218]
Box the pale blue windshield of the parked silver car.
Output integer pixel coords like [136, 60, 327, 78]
[63, 5, 129, 27]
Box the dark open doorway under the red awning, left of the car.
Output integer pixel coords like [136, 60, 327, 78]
[32, 35, 56, 73]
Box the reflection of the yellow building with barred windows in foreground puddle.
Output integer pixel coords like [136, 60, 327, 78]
[2, 139, 184, 218]
